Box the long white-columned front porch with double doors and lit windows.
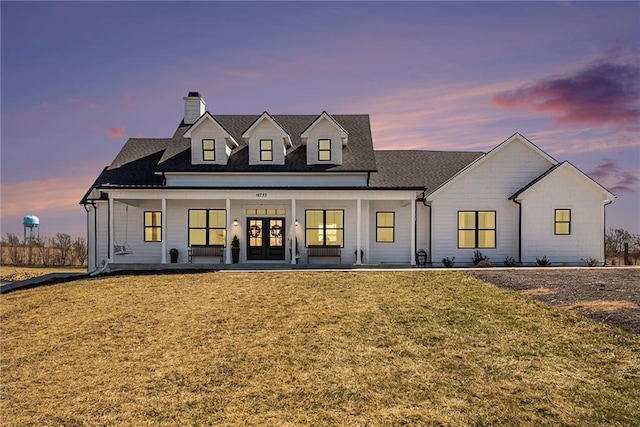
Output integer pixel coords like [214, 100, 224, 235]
[88, 189, 429, 271]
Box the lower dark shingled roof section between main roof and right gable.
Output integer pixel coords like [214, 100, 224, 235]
[369, 150, 483, 191]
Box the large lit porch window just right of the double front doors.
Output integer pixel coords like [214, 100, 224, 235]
[305, 209, 344, 247]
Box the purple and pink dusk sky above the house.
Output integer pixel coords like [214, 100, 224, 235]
[0, 1, 640, 237]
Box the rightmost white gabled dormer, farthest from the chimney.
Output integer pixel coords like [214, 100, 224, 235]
[300, 111, 349, 165]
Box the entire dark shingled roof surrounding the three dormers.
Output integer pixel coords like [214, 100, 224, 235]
[80, 115, 482, 203]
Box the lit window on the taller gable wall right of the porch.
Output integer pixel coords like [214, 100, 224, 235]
[458, 211, 496, 249]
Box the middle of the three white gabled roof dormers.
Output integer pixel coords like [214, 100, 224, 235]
[242, 111, 292, 165]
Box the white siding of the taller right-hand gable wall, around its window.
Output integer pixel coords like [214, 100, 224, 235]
[431, 139, 553, 266]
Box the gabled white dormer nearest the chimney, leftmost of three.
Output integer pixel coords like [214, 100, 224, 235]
[184, 111, 238, 165]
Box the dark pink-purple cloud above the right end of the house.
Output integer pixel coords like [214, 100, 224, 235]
[492, 61, 640, 129]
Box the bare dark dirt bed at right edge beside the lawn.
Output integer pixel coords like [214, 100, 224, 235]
[468, 267, 640, 335]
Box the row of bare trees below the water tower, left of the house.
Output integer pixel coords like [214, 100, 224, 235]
[1, 233, 88, 266]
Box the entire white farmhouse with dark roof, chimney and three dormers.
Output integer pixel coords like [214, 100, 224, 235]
[80, 92, 615, 271]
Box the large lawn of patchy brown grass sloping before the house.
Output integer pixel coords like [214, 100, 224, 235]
[0, 272, 640, 426]
